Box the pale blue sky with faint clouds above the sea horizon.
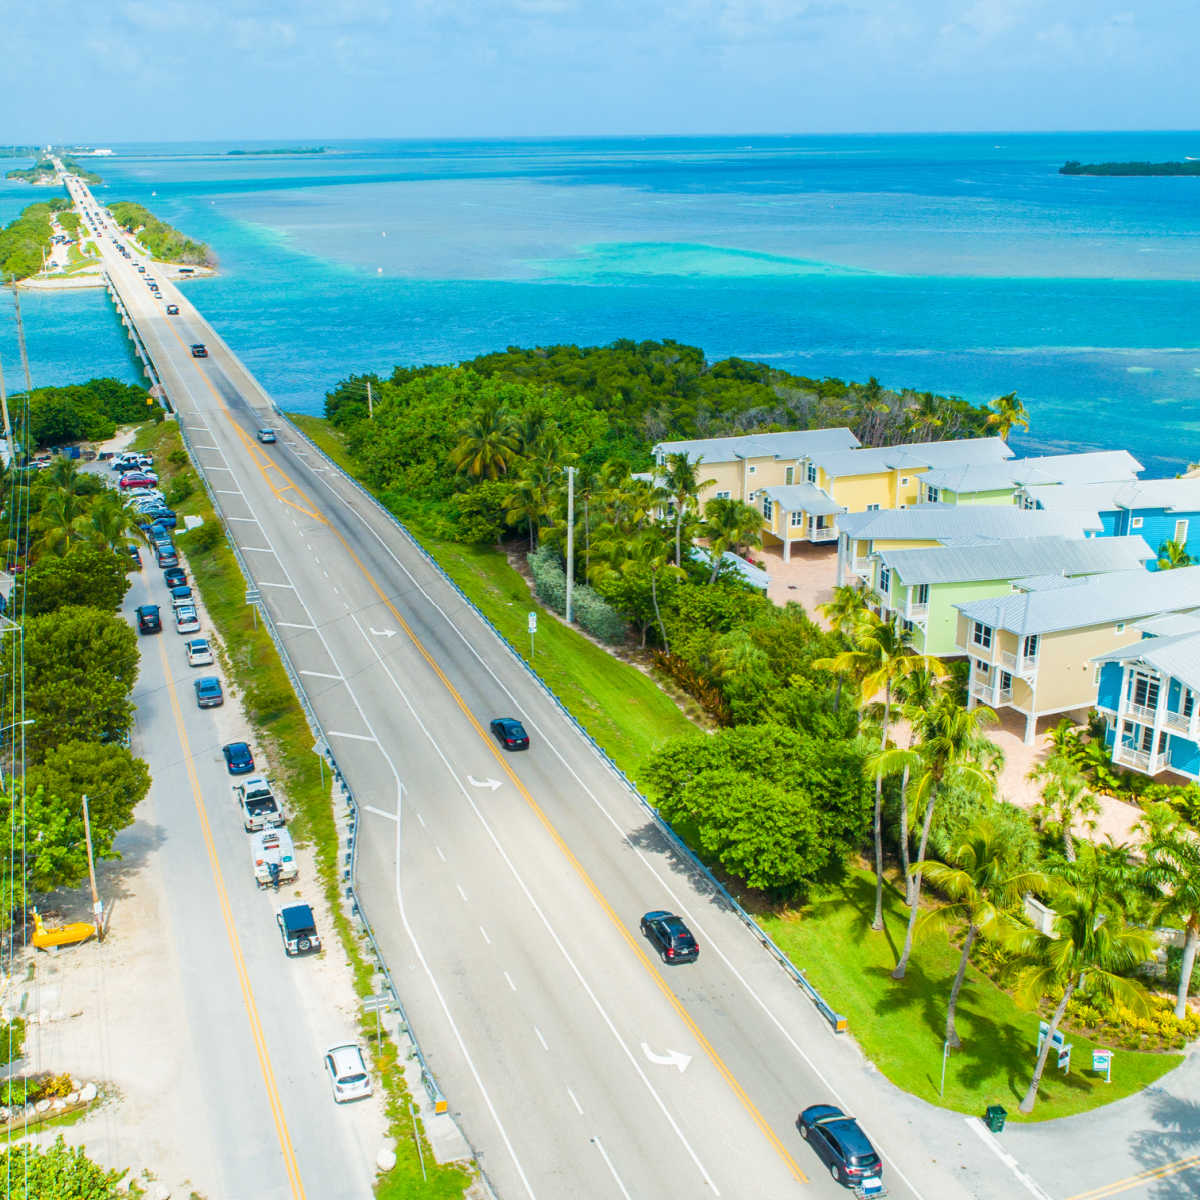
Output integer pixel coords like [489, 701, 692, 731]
[0, 0, 1200, 144]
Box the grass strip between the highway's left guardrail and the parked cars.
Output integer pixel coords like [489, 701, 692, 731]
[134, 420, 470, 1200]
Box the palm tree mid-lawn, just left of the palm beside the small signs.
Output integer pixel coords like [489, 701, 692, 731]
[913, 817, 1050, 1048]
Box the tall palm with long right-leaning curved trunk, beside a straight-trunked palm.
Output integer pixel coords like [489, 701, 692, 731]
[868, 694, 1000, 979]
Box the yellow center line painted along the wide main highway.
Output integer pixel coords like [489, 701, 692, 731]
[147, 285, 809, 1183]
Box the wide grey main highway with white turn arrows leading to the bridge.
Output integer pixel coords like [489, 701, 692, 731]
[63, 175, 1002, 1200]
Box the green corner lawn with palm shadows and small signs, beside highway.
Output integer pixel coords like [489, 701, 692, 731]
[760, 870, 1183, 1121]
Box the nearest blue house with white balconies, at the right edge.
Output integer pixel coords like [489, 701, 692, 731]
[1092, 611, 1200, 780]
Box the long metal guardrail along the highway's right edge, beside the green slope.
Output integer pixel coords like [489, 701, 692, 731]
[275, 406, 850, 1033]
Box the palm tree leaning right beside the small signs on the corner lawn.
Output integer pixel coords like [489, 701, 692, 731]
[1009, 887, 1154, 1112]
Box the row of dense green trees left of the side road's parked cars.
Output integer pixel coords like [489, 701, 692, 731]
[0, 458, 150, 907]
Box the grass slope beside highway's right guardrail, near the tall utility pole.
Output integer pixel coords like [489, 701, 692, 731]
[285, 415, 696, 779]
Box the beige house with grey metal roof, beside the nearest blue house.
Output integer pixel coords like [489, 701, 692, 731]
[955, 566, 1200, 744]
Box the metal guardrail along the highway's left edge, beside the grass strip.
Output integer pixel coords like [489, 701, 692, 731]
[171, 421, 498, 1200]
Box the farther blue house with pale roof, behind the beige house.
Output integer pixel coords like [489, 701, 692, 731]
[1018, 478, 1200, 570]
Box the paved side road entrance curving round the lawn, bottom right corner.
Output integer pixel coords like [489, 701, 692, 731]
[1001, 1048, 1200, 1200]
